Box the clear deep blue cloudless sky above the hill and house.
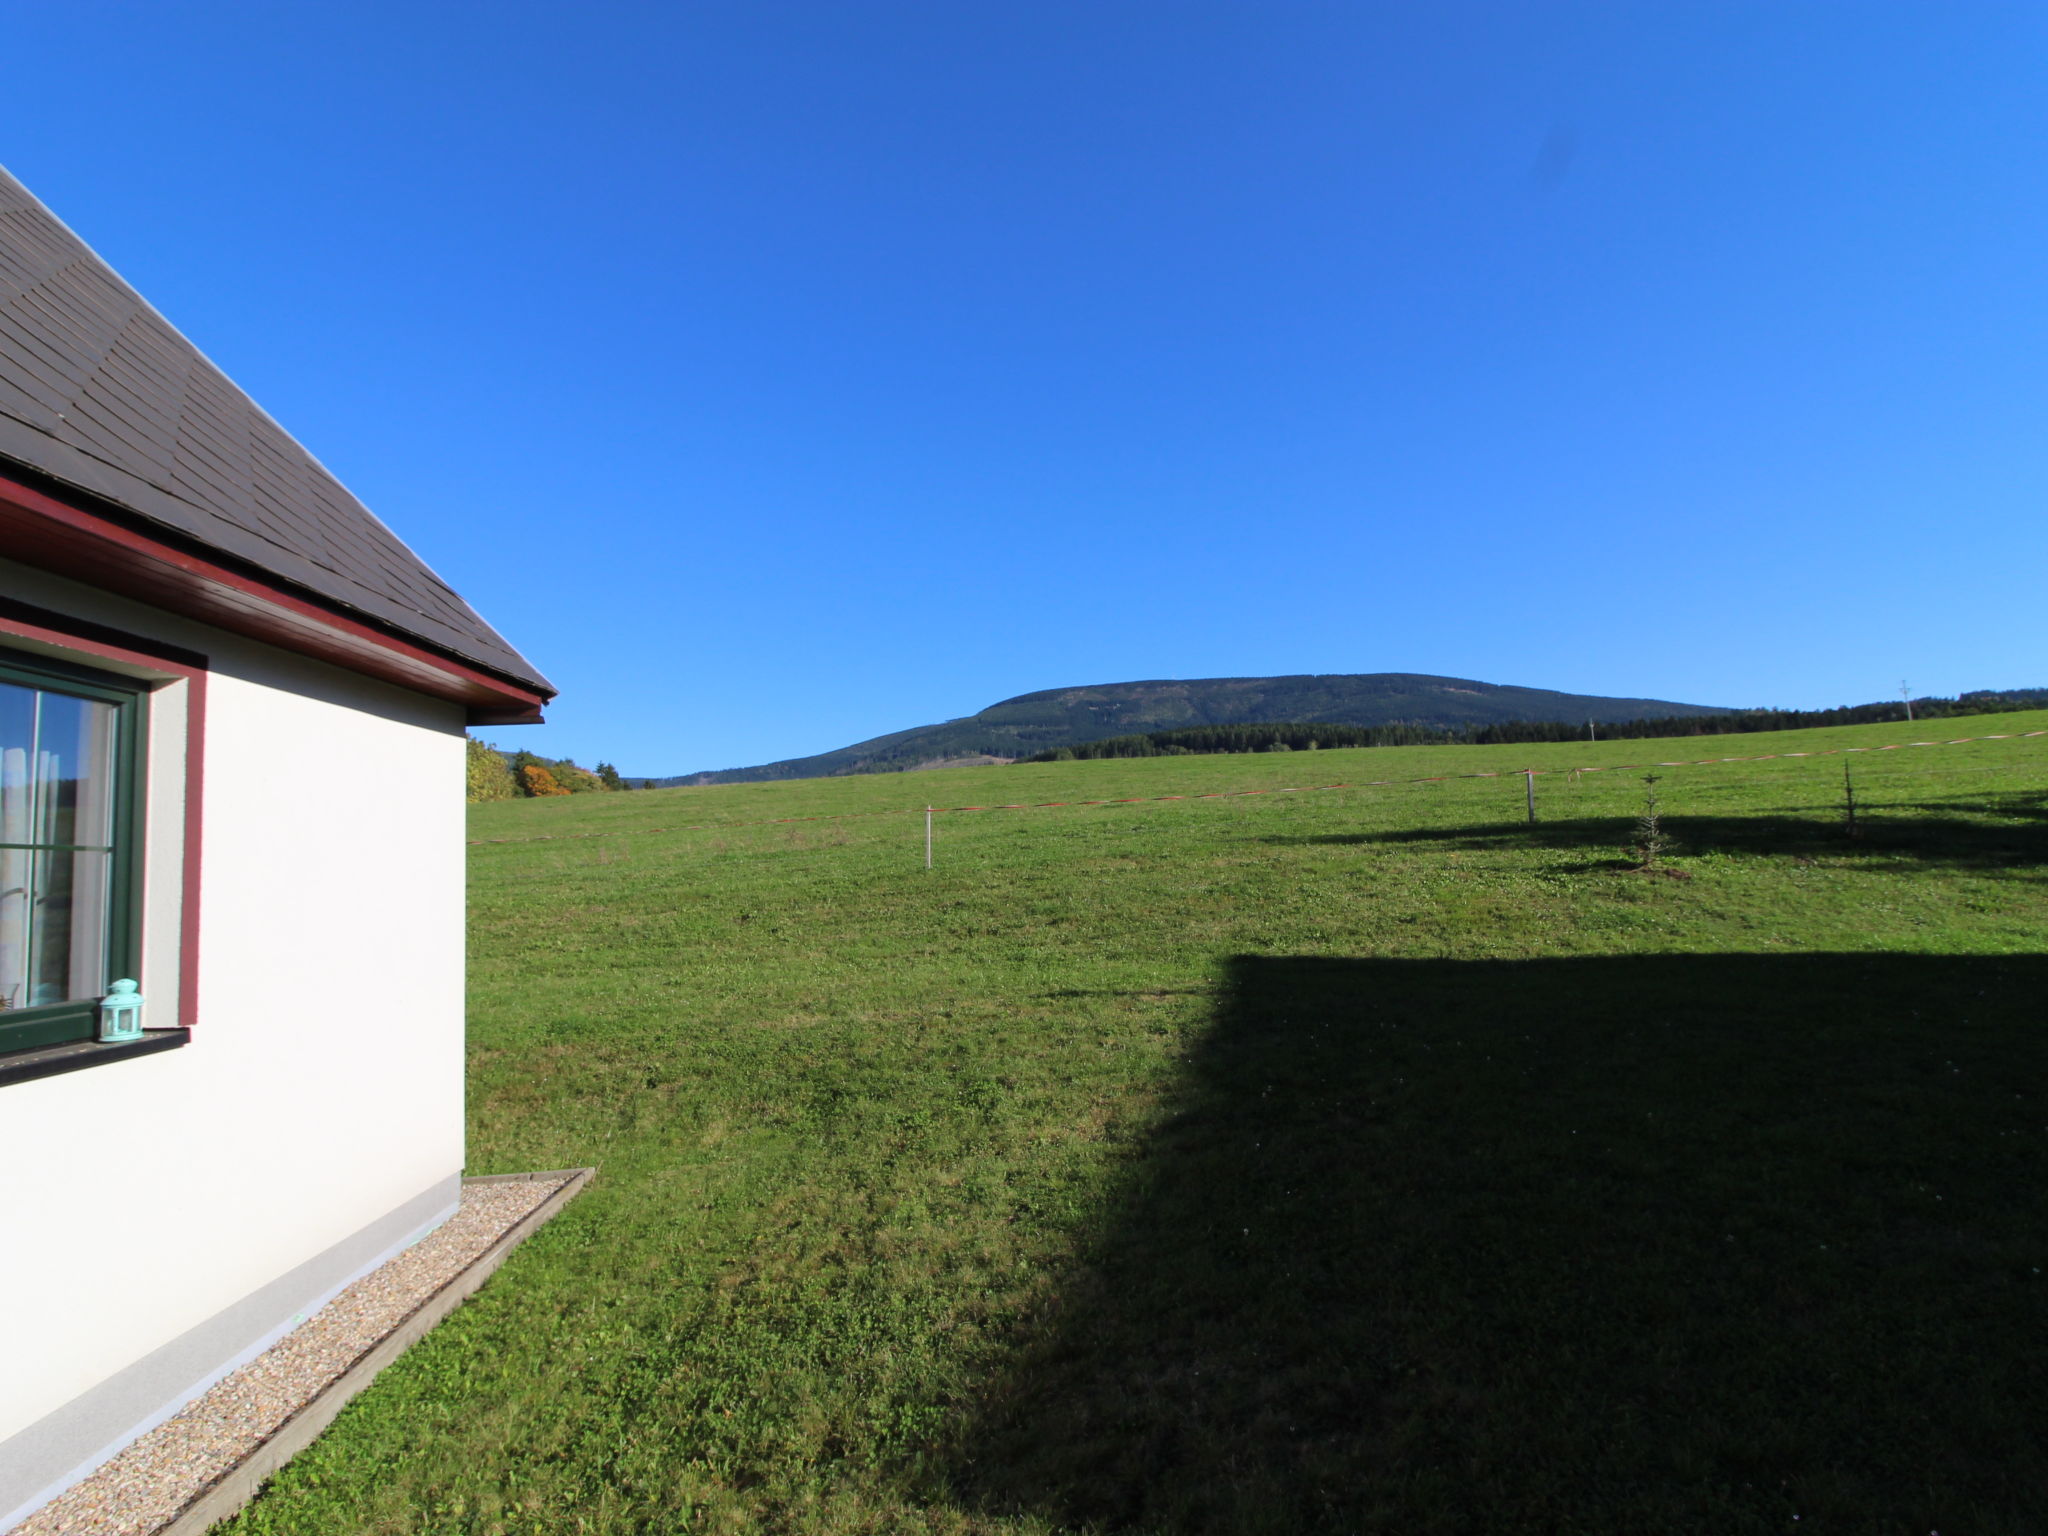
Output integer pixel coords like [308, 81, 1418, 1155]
[0, 0, 2048, 774]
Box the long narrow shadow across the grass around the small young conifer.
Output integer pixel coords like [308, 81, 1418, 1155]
[1270, 795, 2048, 868]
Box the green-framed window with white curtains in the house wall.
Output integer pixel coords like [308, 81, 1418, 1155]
[0, 651, 150, 1053]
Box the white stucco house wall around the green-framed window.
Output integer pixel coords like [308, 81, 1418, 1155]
[0, 561, 463, 1466]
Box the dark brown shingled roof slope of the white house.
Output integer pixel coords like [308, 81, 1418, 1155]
[0, 170, 553, 692]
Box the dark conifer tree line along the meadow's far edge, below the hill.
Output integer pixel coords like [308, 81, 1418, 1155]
[1022, 688, 2048, 762]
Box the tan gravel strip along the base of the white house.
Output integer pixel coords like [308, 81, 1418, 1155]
[12, 1178, 569, 1536]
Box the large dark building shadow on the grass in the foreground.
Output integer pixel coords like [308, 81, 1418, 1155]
[946, 954, 2048, 1536]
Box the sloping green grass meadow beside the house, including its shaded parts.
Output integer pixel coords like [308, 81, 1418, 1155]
[221, 713, 2048, 1536]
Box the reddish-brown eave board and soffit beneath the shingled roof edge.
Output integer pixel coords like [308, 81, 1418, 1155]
[0, 475, 553, 725]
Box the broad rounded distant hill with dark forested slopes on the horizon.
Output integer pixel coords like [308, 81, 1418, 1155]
[637, 672, 1731, 788]
